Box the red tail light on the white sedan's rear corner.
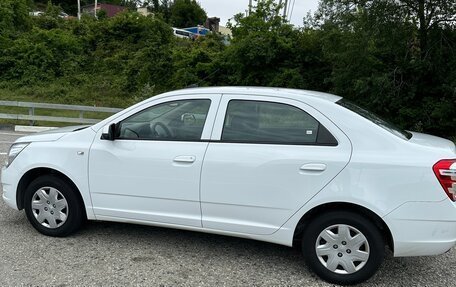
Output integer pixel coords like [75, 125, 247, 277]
[432, 159, 456, 201]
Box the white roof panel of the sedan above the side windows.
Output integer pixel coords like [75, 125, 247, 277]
[167, 87, 342, 102]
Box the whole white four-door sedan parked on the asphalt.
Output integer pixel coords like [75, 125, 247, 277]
[1, 87, 456, 284]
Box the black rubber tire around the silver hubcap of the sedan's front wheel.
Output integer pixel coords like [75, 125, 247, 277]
[24, 175, 85, 237]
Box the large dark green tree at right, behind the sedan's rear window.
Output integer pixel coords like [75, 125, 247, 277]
[307, 0, 456, 135]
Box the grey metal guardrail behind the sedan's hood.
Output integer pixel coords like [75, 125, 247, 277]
[0, 101, 122, 125]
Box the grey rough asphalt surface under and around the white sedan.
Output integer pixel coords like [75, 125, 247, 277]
[0, 131, 456, 286]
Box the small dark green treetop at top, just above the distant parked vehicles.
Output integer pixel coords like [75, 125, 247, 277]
[170, 0, 207, 28]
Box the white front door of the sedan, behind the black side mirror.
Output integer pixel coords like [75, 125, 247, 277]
[89, 95, 220, 227]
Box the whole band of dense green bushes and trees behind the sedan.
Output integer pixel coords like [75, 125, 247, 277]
[0, 0, 456, 140]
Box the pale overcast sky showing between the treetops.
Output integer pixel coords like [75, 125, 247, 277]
[197, 0, 319, 26]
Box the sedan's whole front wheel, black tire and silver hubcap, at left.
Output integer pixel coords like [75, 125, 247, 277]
[25, 175, 83, 237]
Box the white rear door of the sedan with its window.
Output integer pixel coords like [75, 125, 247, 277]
[201, 95, 351, 235]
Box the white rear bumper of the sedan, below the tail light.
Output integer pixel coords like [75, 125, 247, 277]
[384, 199, 456, 257]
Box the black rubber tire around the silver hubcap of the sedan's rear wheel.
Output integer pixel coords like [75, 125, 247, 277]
[302, 211, 385, 285]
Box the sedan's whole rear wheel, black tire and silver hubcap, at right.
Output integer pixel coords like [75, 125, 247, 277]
[302, 211, 385, 285]
